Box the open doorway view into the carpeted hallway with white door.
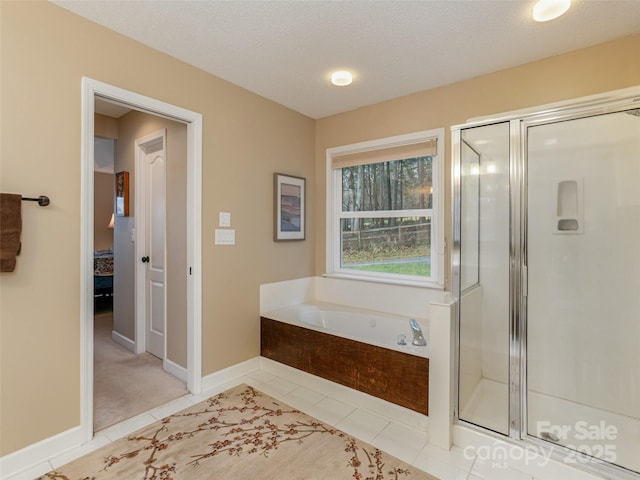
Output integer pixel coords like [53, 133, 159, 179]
[93, 120, 187, 432]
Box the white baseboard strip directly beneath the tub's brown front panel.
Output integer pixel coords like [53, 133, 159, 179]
[260, 357, 429, 431]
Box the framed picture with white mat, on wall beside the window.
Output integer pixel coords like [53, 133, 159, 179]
[273, 173, 306, 242]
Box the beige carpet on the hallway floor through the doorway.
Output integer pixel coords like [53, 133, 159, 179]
[93, 311, 187, 432]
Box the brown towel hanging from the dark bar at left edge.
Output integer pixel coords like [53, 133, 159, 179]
[0, 193, 22, 272]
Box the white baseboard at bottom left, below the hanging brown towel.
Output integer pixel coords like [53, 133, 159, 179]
[0, 426, 82, 480]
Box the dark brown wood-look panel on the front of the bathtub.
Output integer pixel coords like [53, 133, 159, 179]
[260, 317, 429, 415]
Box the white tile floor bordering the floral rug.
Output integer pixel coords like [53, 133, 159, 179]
[10, 369, 624, 480]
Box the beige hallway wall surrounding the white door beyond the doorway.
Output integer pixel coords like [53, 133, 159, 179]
[113, 111, 187, 368]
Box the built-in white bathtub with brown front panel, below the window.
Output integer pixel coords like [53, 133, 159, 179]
[260, 303, 429, 415]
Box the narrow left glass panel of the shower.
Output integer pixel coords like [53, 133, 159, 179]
[454, 122, 509, 435]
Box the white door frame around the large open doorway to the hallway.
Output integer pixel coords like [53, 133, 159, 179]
[80, 77, 202, 443]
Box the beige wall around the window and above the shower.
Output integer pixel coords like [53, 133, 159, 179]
[315, 35, 640, 285]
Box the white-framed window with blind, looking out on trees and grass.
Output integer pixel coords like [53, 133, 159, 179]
[327, 129, 444, 288]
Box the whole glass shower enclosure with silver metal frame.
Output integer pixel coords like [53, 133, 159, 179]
[452, 88, 640, 478]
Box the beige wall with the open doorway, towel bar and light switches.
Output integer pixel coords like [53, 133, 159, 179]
[0, 1, 314, 455]
